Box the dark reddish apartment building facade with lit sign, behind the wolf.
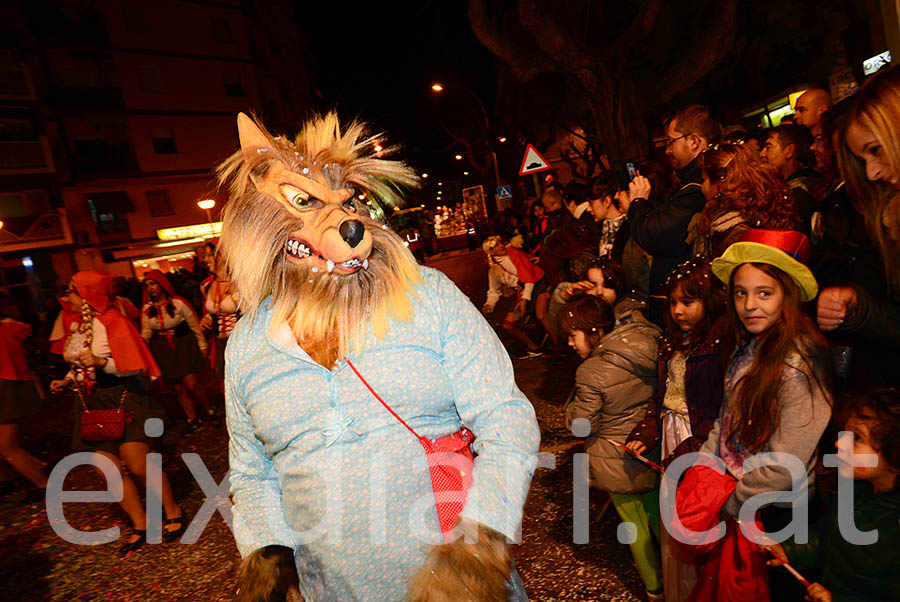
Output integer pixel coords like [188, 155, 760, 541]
[0, 0, 312, 310]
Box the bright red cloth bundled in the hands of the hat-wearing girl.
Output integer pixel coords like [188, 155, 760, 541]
[669, 463, 769, 602]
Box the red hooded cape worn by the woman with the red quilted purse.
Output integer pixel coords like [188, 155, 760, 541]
[72, 270, 162, 376]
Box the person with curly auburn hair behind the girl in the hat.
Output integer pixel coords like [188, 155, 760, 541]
[687, 143, 801, 258]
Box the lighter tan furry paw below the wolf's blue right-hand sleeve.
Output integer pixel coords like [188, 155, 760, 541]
[407, 520, 512, 602]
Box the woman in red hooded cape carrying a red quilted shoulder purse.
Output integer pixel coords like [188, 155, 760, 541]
[50, 270, 186, 556]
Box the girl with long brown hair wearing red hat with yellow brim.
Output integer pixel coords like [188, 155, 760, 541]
[695, 229, 832, 591]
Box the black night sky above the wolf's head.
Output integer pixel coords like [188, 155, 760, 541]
[296, 0, 496, 177]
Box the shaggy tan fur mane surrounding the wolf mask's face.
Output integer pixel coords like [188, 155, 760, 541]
[219, 113, 420, 368]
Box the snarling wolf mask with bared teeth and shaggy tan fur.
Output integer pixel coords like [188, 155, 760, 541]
[219, 113, 419, 369]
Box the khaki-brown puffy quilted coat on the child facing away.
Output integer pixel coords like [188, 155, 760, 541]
[566, 309, 659, 493]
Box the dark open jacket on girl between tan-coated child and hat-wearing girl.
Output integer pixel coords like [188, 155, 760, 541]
[628, 316, 733, 465]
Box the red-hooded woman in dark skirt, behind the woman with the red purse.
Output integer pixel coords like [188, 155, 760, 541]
[141, 270, 216, 432]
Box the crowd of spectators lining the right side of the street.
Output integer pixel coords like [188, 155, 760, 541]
[474, 69, 900, 601]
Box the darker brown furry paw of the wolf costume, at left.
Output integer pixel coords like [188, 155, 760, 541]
[234, 546, 303, 602]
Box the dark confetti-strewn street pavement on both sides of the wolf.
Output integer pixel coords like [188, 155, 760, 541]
[0, 250, 644, 602]
